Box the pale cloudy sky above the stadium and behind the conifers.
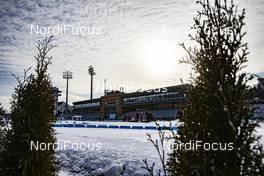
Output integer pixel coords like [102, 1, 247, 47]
[0, 0, 264, 109]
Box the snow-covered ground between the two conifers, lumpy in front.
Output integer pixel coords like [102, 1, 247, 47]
[55, 122, 264, 176]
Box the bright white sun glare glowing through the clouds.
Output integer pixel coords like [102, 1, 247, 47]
[142, 38, 179, 76]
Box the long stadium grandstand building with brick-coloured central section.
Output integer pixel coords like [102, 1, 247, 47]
[71, 85, 187, 121]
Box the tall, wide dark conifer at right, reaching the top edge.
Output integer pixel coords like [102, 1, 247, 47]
[167, 0, 264, 176]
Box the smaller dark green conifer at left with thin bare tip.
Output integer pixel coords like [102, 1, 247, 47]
[3, 37, 57, 176]
